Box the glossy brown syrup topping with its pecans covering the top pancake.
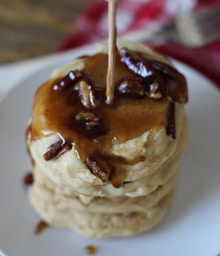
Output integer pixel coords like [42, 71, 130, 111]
[27, 48, 187, 183]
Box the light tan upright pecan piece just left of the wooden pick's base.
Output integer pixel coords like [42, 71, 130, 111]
[79, 80, 98, 108]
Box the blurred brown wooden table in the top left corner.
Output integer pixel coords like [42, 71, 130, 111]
[0, 0, 91, 64]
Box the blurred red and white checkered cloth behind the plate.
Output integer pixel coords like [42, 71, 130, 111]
[58, 0, 220, 87]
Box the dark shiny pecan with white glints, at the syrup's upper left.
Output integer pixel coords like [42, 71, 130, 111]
[53, 70, 82, 91]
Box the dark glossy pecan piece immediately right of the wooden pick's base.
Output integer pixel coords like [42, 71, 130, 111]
[116, 79, 145, 98]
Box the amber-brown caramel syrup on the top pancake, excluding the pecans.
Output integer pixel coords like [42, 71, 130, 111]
[32, 54, 167, 161]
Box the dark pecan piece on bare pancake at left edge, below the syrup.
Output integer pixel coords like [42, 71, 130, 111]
[44, 140, 72, 161]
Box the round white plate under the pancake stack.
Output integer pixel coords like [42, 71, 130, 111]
[0, 48, 220, 256]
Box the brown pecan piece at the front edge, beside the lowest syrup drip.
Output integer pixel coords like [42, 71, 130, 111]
[86, 155, 111, 182]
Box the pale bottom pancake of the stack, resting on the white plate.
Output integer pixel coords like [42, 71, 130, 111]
[29, 167, 176, 238]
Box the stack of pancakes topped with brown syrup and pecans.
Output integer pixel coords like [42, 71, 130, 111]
[26, 42, 187, 238]
